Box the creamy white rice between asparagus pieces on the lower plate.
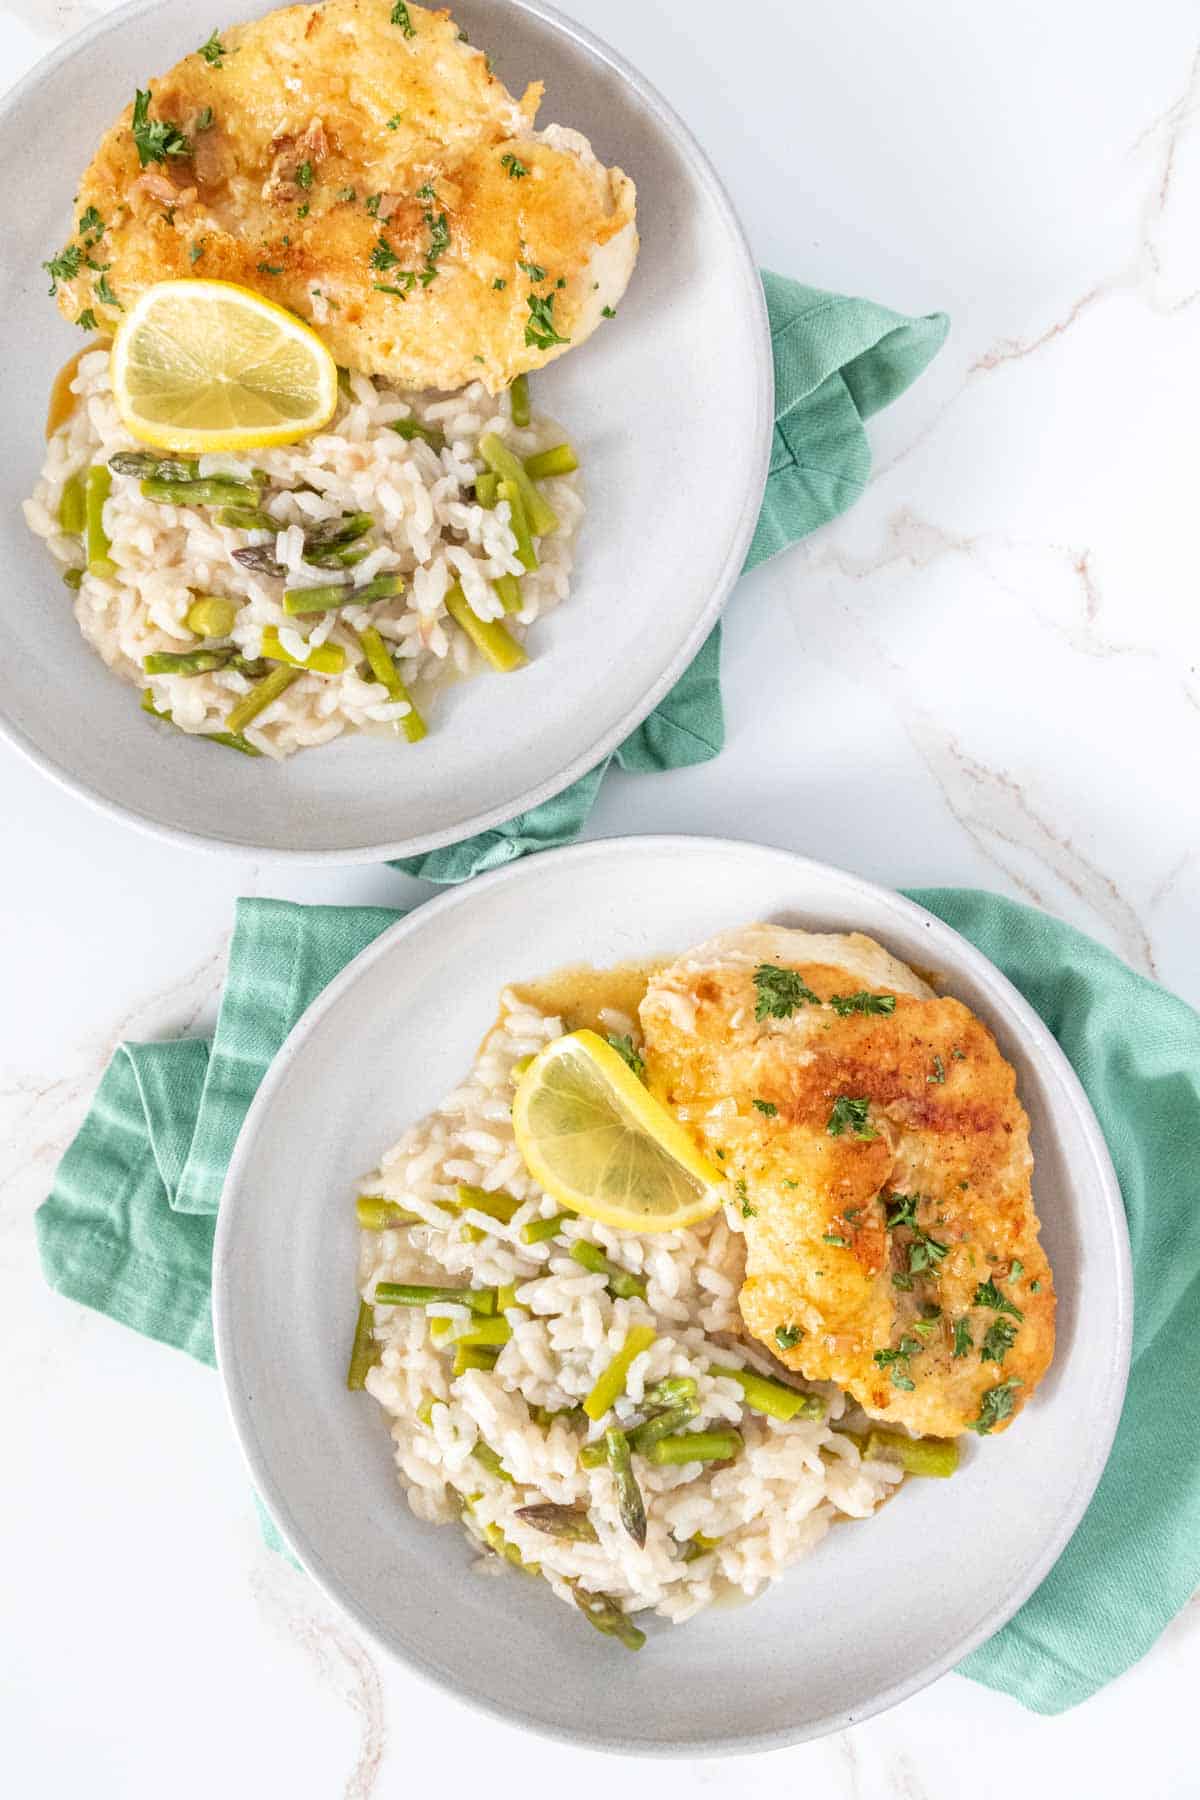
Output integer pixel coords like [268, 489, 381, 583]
[360, 992, 901, 1622]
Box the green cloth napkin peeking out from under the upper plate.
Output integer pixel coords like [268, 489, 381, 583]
[396, 272, 950, 882]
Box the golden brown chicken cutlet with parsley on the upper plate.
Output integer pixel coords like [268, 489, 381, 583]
[49, 0, 637, 392]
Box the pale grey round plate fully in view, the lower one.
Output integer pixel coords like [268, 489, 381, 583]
[212, 837, 1132, 1753]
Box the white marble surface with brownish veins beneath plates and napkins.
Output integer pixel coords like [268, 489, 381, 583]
[0, 0, 1200, 1800]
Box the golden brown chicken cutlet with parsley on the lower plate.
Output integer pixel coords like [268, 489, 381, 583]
[640, 925, 1054, 1436]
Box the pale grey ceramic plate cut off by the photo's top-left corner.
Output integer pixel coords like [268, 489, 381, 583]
[0, 0, 772, 862]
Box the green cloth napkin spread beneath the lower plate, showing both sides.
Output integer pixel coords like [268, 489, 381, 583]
[38, 887, 1200, 1712]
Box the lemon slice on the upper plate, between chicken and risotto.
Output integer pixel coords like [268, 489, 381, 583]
[112, 281, 338, 455]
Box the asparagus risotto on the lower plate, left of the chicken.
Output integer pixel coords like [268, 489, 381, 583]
[351, 992, 901, 1649]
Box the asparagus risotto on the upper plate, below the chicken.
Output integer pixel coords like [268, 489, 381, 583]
[25, 349, 583, 758]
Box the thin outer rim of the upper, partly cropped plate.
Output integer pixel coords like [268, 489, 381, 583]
[0, 0, 775, 866]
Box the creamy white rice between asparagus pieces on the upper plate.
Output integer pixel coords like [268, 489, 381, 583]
[25, 349, 583, 758]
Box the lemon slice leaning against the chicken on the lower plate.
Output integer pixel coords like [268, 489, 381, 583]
[513, 1031, 723, 1231]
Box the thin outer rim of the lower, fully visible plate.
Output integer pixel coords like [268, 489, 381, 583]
[212, 833, 1133, 1759]
